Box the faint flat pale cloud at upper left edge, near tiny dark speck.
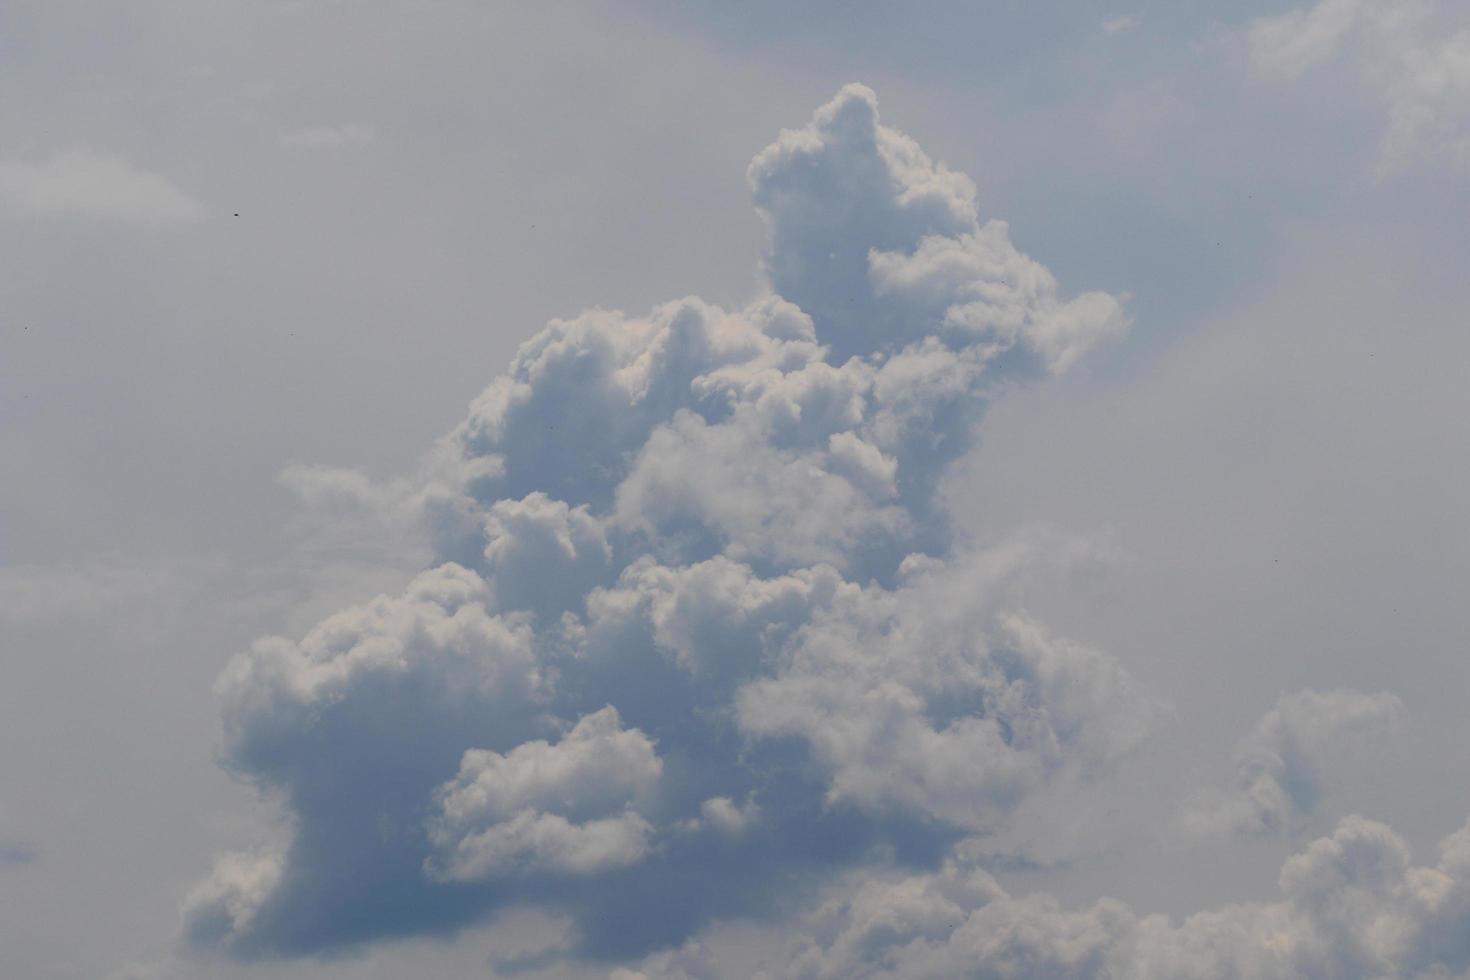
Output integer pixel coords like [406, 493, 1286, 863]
[0, 151, 203, 225]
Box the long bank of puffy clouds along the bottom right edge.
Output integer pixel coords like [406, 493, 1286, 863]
[613, 817, 1470, 980]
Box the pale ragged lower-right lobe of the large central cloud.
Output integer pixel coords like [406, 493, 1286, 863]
[735, 542, 1152, 830]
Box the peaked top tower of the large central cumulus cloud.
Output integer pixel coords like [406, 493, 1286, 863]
[750, 85, 1126, 369]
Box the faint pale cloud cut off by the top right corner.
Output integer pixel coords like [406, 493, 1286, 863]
[1250, 0, 1470, 166]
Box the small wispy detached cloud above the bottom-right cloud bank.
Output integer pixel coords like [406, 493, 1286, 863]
[1183, 691, 1404, 839]
